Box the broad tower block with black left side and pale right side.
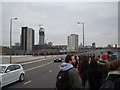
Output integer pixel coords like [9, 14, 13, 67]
[21, 27, 34, 51]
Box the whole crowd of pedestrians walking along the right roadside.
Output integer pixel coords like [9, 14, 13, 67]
[56, 51, 120, 90]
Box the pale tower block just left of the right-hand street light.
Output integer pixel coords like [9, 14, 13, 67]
[67, 34, 78, 52]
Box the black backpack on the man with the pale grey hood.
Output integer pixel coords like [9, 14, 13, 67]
[56, 70, 69, 90]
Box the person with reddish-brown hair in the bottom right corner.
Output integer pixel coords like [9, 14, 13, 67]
[100, 60, 120, 90]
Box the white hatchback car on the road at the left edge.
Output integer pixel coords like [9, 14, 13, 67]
[0, 64, 25, 87]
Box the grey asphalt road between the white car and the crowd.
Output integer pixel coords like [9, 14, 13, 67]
[2, 57, 60, 90]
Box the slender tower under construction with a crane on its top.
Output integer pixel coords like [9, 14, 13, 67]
[39, 26, 45, 45]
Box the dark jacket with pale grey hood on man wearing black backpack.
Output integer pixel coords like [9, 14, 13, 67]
[60, 63, 82, 90]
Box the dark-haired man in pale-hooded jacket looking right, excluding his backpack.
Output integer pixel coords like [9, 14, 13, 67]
[56, 55, 83, 90]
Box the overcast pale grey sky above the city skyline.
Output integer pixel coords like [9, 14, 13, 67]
[0, 2, 118, 46]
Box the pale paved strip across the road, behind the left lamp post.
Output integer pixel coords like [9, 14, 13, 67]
[0, 55, 65, 64]
